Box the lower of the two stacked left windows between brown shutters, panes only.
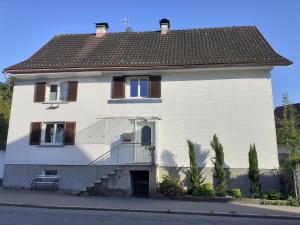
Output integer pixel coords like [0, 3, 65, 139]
[44, 123, 65, 144]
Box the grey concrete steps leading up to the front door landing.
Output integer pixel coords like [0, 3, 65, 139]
[78, 167, 129, 196]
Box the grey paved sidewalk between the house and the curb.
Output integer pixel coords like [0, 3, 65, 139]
[0, 189, 300, 219]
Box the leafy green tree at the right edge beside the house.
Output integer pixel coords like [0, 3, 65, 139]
[276, 93, 300, 157]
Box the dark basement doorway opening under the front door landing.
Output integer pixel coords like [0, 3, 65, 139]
[130, 170, 149, 196]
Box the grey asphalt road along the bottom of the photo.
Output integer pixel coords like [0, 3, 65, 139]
[0, 206, 300, 225]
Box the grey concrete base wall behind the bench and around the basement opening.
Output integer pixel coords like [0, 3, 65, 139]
[3, 164, 156, 195]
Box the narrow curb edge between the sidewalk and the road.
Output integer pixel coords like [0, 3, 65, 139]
[0, 202, 300, 220]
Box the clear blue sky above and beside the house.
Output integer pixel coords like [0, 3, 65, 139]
[0, 0, 300, 106]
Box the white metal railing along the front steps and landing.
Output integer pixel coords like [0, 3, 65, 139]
[89, 143, 154, 165]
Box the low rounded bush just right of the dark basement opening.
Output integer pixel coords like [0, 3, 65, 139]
[157, 175, 184, 196]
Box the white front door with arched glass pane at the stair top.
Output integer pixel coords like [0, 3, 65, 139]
[135, 121, 155, 163]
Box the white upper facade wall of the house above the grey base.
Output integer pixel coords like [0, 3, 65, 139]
[6, 69, 278, 169]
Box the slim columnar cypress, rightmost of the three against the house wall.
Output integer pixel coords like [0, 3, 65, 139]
[248, 144, 261, 197]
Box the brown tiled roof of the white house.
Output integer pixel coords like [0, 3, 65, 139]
[5, 26, 292, 74]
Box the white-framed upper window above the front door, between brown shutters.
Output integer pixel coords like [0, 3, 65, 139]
[128, 77, 149, 98]
